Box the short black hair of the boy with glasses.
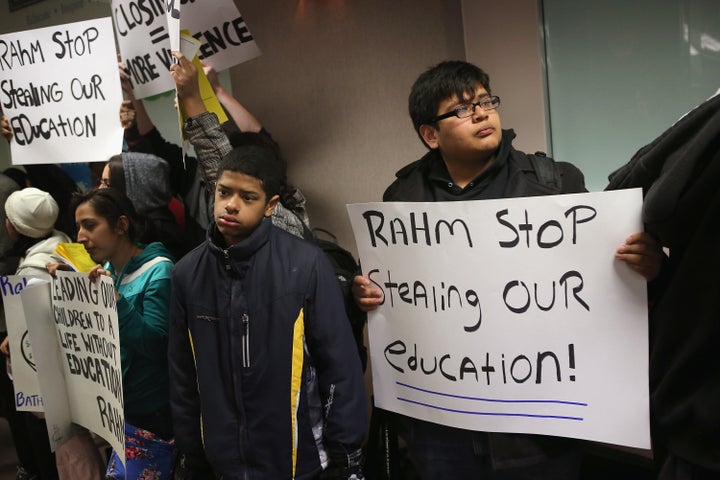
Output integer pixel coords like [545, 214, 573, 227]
[408, 60, 490, 146]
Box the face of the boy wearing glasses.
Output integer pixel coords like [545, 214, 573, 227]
[421, 86, 502, 166]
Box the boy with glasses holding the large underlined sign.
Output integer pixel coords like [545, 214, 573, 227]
[353, 61, 661, 480]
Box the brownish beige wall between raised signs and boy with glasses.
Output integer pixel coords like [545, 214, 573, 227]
[231, 0, 465, 250]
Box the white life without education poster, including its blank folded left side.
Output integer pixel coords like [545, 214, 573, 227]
[21, 272, 125, 456]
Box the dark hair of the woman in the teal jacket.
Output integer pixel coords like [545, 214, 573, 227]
[70, 187, 145, 243]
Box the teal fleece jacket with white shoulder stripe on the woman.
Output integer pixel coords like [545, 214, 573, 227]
[105, 242, 174, 415]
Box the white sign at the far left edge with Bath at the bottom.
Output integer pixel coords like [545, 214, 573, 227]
[0, 275, 43, 412]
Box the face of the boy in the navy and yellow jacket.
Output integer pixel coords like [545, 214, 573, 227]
[215, 170, 278, 247]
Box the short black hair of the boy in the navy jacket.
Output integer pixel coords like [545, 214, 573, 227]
[217, 145, 286, 200]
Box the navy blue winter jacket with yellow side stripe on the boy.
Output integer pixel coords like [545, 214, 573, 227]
[169, 219, 367, 479]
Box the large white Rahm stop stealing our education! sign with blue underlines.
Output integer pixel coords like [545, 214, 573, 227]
[348, 190, 650, 448]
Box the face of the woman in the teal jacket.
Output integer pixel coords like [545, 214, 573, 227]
[75, 202, 123, 263]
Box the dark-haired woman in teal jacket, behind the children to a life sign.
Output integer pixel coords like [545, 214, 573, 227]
[73, 188, 173, 440]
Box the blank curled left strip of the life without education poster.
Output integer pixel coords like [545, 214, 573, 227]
[20, 281, 73, 451]
